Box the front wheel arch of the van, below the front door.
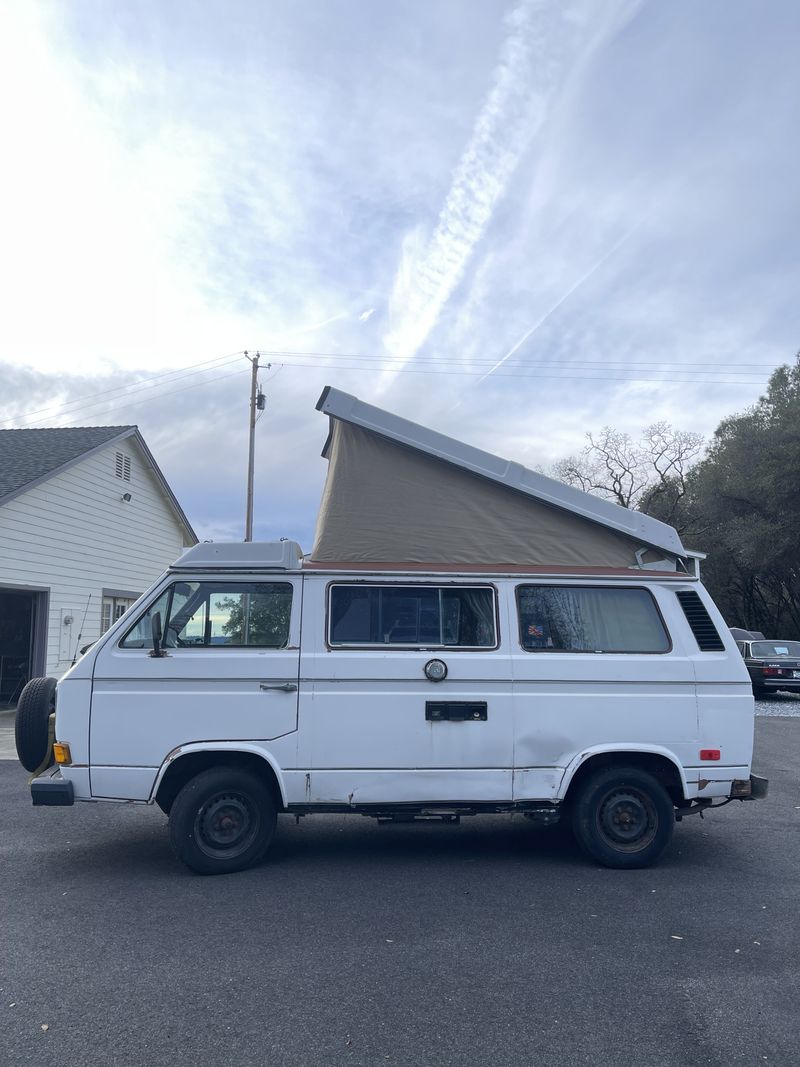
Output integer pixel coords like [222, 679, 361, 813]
[147, 742, 286, 814]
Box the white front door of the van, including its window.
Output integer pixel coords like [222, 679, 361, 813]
[90, 576, 301, 800]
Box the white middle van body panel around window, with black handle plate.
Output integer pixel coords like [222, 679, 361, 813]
[299, 575, 513, 803]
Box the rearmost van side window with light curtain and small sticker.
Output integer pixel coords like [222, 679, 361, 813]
[516, 586, 671, 652]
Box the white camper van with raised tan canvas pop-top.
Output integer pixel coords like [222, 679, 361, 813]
[17, 389, 767, 874]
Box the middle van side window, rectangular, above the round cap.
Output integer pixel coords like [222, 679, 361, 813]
[327, 583, 497, 649]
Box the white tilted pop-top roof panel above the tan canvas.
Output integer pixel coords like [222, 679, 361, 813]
[317, 386, 687, 558]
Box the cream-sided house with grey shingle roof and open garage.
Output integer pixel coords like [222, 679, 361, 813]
[0, 426, 197, 704]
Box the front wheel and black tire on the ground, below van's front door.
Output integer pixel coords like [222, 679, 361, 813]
[170, 766, 276, 874]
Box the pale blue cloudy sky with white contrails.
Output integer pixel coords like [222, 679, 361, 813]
[0, 0, 800, 551]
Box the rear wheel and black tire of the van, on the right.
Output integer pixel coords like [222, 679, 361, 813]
[571, 766, 675, 869]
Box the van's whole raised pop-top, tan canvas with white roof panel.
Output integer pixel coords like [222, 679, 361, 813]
[310, 387, 690, 571]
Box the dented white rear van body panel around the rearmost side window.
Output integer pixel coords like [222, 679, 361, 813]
[510, 579, 699, 800]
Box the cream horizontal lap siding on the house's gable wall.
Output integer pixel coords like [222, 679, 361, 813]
[0, 437, 193, 678]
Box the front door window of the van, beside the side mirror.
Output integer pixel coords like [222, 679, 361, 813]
[119, 582, 292, 649]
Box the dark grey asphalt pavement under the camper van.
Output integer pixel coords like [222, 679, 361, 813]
[0, 717, 800, 1067]
